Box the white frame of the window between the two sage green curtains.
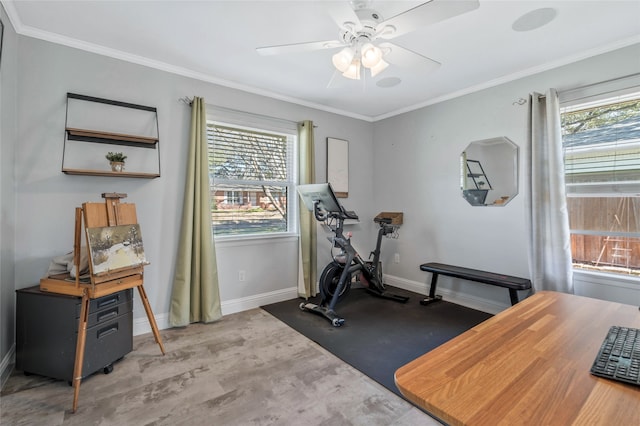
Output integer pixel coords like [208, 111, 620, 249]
[207, 105, 299, 241]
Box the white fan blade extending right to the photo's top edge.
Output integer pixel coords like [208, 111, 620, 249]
[376, 0, 480, 39]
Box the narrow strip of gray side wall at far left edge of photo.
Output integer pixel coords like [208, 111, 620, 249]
[0, 6, 18, 384]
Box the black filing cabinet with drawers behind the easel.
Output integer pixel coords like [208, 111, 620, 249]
[16, 286, 133, 383]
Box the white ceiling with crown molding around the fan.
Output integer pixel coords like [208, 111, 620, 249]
[2, 0, 640, 121]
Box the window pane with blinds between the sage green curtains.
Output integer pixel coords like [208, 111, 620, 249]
[207, 121, 296, 236]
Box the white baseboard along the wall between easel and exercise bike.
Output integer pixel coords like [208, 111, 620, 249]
[133, 287, 298, 336]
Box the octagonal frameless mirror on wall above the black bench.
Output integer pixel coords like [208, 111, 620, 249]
[460, 137, 518, 206]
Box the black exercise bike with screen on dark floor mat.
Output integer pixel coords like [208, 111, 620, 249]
[298, 183, 409, 327]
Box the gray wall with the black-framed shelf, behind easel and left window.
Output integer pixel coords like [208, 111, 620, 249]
[10, 37, 373, 336]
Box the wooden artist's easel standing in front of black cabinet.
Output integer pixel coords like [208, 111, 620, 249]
[40, 193, 165, 413]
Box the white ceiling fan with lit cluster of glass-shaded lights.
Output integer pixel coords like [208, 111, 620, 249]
[256, 0, 480, 80]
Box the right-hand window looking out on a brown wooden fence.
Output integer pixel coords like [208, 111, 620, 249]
[561, 93, 640, 276]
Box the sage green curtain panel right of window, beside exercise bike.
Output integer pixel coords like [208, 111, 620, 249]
[298, 121, 318, 298]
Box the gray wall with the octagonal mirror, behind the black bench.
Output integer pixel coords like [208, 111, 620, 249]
[373, 45, 640, 312]
